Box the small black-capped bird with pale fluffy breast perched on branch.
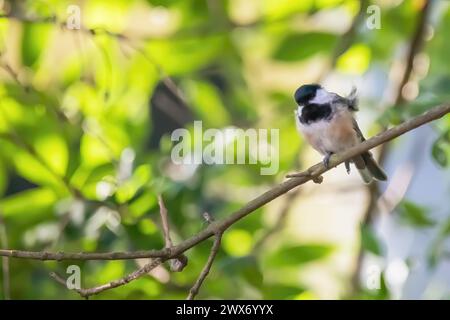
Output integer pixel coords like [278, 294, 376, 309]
[294, 84, 387, 183]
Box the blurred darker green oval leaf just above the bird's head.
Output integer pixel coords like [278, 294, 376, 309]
[273, 32, 336, 61]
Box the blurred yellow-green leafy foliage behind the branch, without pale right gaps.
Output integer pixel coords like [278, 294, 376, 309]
[0, 0, 450, 299]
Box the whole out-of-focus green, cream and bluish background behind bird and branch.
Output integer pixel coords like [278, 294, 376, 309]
[0, 0, 450, 299]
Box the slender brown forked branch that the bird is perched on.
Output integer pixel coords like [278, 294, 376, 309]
[0, 103, 450, 296]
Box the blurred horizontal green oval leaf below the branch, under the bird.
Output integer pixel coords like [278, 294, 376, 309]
[267, 244, 333, 267]
